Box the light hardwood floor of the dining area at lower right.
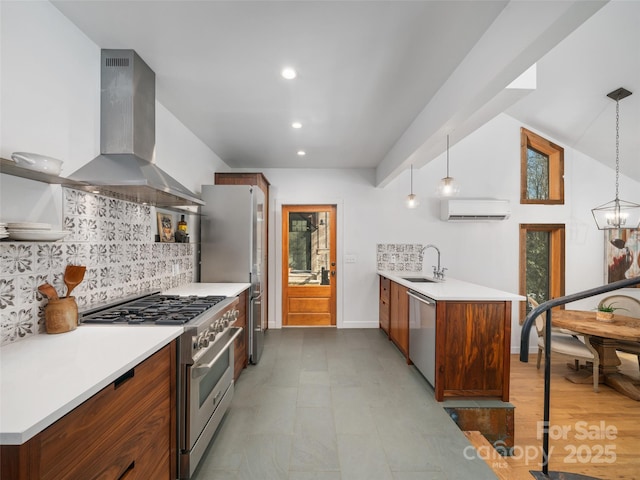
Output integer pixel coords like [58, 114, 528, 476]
[507, 354, 640, 480]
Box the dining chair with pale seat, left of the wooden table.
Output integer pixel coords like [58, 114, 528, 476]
[527, 296, 600, 392]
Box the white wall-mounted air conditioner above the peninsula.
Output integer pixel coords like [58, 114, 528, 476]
[440, 198, 511, 222]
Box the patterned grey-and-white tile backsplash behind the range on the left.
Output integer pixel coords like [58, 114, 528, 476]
[0, 188, 196, 345]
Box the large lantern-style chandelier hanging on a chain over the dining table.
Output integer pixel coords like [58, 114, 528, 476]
[591, 88, 640, 230]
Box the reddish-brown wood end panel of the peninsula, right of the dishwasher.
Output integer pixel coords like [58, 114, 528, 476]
[435, 301, 511, 402]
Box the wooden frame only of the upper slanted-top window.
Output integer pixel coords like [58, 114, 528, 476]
[520, 127, 564, 205]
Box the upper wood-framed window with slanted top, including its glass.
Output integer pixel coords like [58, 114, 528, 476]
[520, 128, 564, 204]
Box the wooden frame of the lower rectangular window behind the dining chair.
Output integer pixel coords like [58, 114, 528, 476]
[519, 223, 566, 325]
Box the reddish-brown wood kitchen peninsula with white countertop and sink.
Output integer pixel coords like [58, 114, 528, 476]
[378, 271, 525, 402]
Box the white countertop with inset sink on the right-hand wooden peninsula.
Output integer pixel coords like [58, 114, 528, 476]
[378, 270, 525, 301]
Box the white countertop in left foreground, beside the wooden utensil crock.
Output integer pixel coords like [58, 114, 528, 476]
[0, 325, 183, 445]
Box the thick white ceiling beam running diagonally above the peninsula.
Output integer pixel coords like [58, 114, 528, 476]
[376, 0, 607, 187]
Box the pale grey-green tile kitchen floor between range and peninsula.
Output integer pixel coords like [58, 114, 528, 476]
[193, 328, 496, 480]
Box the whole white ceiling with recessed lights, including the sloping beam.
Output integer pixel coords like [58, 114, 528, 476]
[52, 0, 640, 185]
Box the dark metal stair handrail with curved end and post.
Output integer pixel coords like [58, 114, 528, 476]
[520, 276, 640, 478]
